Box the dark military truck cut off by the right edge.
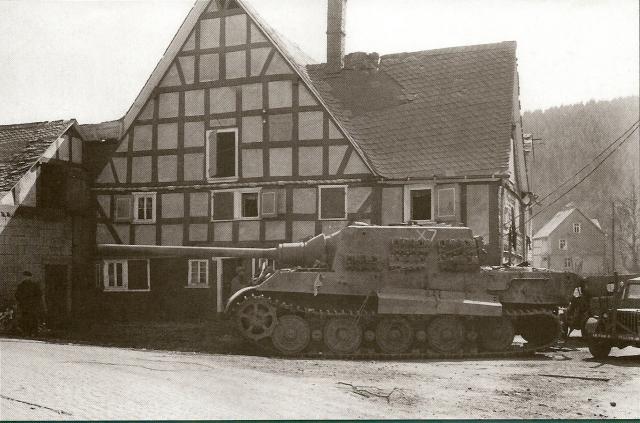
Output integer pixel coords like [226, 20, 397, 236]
[585, 277, 640, 359]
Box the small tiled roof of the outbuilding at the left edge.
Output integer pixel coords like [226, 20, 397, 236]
[0, 120, 76, 191]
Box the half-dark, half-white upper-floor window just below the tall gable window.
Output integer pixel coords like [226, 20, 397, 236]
[211, 188, 260, 221]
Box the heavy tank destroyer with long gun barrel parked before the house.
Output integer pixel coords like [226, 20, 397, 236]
[99, 224, 580, 357]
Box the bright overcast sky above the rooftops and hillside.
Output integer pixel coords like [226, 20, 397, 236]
[0, 0, 640, 123]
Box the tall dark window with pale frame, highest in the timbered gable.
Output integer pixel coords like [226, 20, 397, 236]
[207, 128, 238, 179]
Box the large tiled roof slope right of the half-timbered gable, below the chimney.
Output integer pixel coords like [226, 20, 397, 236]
[307, 42, 516, 178]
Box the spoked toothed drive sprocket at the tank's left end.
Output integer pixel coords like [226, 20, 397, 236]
[236, 297, 278, 341]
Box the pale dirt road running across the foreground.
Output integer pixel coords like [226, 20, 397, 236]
[0, 339, 640, 420]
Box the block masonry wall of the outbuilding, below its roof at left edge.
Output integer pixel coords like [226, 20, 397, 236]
[0, 206, 72, 310]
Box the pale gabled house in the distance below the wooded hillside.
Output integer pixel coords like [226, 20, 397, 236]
[533, 207, 607, 275]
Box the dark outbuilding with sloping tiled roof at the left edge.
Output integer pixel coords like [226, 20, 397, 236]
[0, 120, 93, 326]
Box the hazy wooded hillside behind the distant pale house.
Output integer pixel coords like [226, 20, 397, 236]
[523, 97, 640, 272]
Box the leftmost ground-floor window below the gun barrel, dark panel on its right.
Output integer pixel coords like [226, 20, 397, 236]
[102, 260, 150, 291]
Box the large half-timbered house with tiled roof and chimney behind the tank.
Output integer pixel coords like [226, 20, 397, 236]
[93, 0, 529, 317]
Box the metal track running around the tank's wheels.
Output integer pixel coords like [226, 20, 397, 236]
[231, 293, 560, 360]
